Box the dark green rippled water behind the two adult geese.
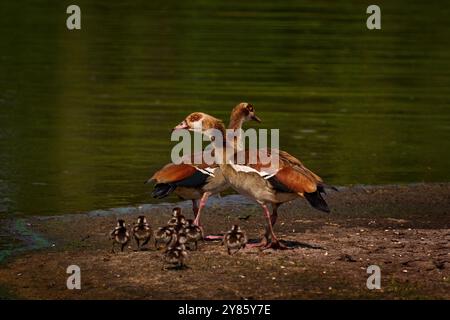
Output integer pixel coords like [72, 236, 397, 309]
[0, 0, 450, 217]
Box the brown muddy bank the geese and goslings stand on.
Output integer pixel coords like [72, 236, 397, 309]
[0, 184, 450, 299]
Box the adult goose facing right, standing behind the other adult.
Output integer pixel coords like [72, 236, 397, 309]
[146, 102, 261, 228]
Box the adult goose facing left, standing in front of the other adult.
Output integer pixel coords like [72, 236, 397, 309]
[174, 112, 330, 249]
